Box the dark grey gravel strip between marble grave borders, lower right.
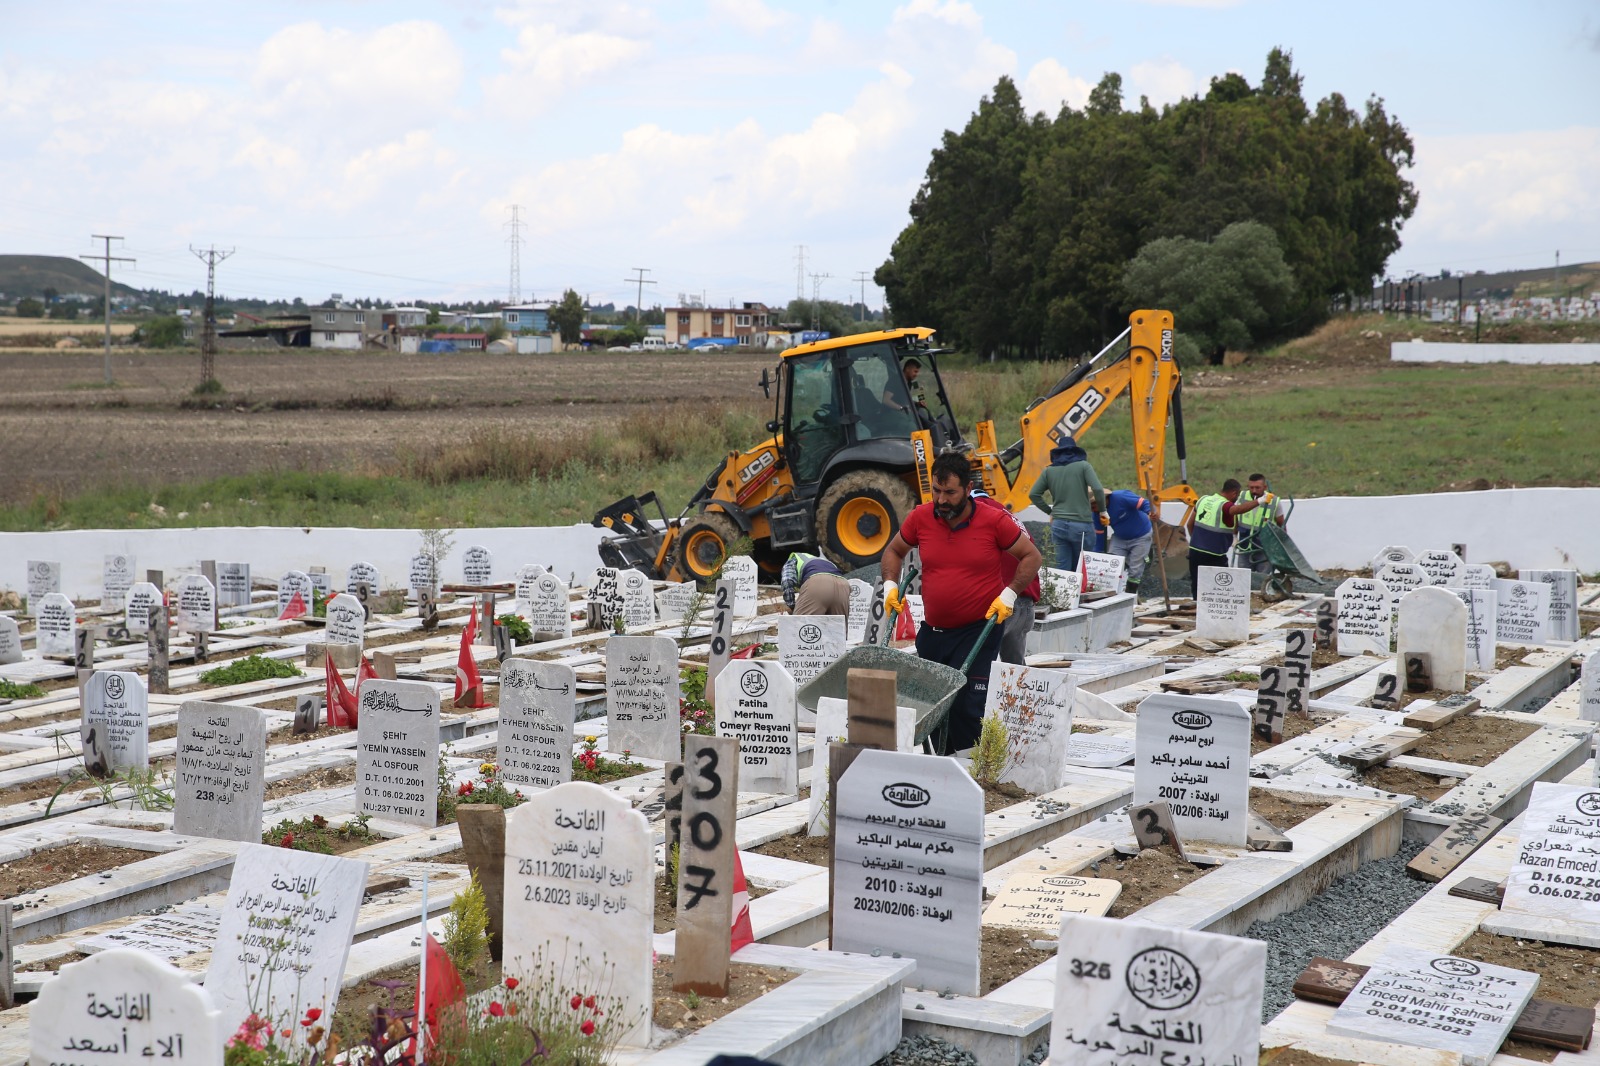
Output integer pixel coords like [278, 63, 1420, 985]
[1245, 840, 1434, 1024]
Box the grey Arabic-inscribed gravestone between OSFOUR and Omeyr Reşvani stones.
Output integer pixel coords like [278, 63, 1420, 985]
[605, 637, 683, 762]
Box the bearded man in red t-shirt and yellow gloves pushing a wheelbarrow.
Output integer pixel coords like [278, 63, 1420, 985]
[883, 451, 1040, 754]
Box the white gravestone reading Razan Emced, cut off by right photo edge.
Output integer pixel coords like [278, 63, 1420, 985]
[1501, 781, 1600, 927]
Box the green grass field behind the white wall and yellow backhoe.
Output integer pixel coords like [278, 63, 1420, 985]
[0, 317, 1600, 530]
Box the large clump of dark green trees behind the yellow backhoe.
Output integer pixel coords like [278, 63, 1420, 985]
[875, 48, 1418, 359]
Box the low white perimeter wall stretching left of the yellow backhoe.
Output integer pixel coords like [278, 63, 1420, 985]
[0, 525, 602, 600]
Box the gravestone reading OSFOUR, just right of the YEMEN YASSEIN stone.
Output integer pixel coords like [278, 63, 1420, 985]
[499, 658, 578, 789]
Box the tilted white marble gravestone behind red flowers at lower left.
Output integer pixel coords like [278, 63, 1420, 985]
[205, 844, 366, 1042]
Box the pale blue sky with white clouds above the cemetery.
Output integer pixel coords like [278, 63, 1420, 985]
[0, 0, 1600, 306]
